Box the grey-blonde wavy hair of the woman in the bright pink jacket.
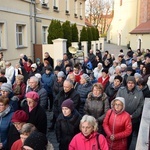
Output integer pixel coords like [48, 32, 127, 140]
[80, 115, 98, 131]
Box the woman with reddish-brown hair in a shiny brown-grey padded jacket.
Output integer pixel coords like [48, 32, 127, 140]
[84, 83, 109, 132]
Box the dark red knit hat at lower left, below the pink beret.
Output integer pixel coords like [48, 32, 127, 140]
[11, 110, 29, 122]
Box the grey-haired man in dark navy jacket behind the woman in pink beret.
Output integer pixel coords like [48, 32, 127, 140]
[27, 76, 48, 109]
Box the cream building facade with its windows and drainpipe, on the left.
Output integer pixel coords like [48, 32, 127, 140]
[0, 0, 85, 63]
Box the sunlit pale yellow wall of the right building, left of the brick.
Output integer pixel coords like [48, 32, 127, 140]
[107, 0, 139, 46]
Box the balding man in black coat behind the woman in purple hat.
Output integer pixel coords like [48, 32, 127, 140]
[49, 79, 80, 130]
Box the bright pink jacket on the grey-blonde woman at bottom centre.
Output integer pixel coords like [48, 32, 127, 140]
[69, 132, 108, 150]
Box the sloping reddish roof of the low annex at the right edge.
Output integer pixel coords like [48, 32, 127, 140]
[130, 21, 150, 34]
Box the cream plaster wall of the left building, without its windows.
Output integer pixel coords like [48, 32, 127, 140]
[0, 0, 85, 65]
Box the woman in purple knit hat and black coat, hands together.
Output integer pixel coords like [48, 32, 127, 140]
[55, 98, 81, 150]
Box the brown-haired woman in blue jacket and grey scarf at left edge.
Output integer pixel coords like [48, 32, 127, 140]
[0, 96, 13, 149]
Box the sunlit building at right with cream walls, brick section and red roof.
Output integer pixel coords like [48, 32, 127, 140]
[107, 0, 150, 50]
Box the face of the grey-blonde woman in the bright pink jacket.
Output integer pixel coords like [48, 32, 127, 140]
[81, 122, 94, 137]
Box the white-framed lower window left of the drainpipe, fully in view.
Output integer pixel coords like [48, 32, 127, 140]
[16, 24, 27, 48]
